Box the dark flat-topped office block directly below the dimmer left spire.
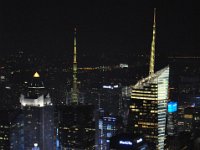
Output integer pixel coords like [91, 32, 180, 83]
[56, 105, 95, 150]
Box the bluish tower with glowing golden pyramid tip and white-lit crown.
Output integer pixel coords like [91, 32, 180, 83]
[10, 72, 55, 150]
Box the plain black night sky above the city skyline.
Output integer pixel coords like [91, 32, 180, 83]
[0, 0, 200, 59]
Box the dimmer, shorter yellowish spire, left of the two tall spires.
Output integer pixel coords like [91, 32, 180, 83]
[71, 28, 78, 104]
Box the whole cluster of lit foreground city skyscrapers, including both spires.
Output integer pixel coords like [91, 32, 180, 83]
[0, 10, 200, 150]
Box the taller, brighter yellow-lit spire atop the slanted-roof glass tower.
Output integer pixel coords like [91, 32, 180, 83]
[149, 8, 156, 75]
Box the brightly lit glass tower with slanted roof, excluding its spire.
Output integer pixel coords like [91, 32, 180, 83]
[128, 67, 169, 150]
